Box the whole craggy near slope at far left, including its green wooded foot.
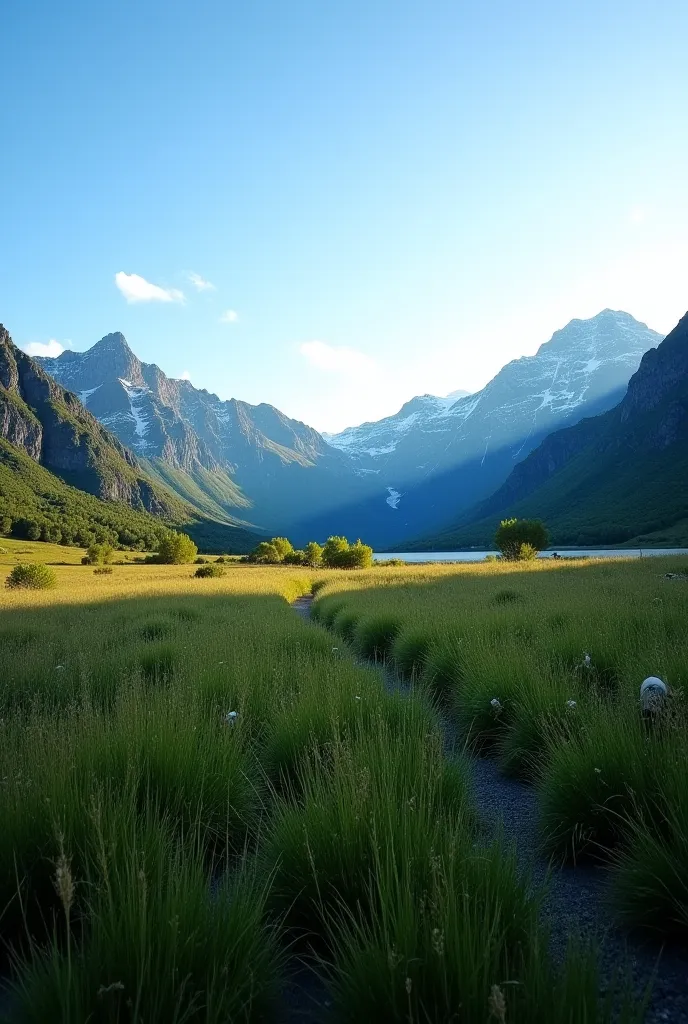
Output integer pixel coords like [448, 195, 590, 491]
[0, 325, 259, 552]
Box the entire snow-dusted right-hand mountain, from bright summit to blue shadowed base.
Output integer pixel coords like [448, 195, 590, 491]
[301, 309, 661, 550]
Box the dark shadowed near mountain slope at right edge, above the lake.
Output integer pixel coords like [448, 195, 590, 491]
[423, 313, 688, 547]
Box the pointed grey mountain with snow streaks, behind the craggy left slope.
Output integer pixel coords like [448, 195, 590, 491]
[41, 334, 366, 530]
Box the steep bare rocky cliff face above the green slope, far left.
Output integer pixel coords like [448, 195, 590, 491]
[0, 326, 177, 514]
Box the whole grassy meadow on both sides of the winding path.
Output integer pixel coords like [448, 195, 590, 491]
[0, 542, 688, 1024]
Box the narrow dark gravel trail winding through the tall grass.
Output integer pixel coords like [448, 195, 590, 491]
[290, 595, 688, 1024]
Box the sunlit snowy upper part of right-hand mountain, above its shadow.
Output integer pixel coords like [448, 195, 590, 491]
[327, 309, 661, 508]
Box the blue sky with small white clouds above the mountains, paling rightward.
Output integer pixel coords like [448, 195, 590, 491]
[0, 0, 688, 430]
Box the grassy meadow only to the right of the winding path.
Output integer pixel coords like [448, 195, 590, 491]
[313, 557, 688, 937]
